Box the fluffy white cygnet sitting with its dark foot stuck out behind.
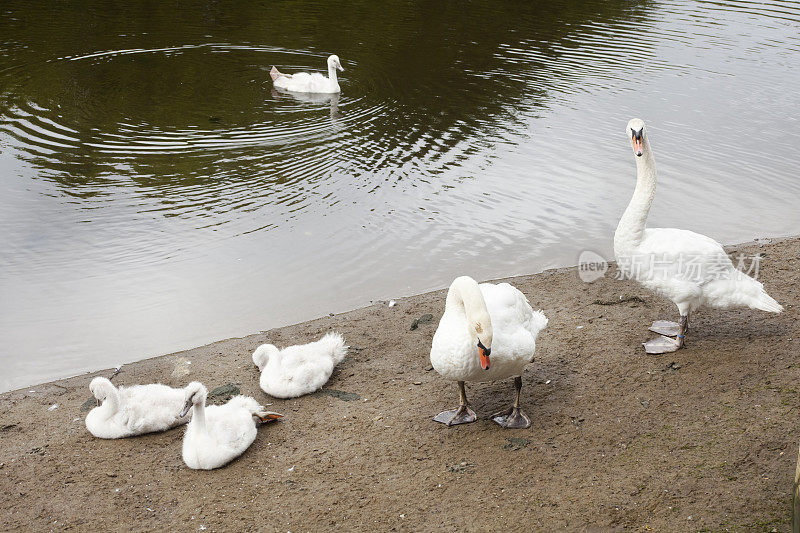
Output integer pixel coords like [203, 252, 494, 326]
[182, 381, 283, 470]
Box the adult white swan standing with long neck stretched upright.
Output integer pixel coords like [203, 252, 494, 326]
[614, 118, 783, 354]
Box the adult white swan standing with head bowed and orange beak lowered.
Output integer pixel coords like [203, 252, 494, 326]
[431, 276, 547, 428]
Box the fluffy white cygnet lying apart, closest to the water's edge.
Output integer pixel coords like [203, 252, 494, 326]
[253, 332, 348, 398]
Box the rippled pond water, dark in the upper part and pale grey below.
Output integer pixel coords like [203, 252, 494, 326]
[0, 0, 800, 389]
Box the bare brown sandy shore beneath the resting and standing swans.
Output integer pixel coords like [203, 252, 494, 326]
[0, 239, 800, 531]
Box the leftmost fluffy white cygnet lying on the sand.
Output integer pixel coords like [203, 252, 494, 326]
[86, 378, 189, 439]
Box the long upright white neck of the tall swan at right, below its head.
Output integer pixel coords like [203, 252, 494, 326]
[614, 137, 656, 254]
